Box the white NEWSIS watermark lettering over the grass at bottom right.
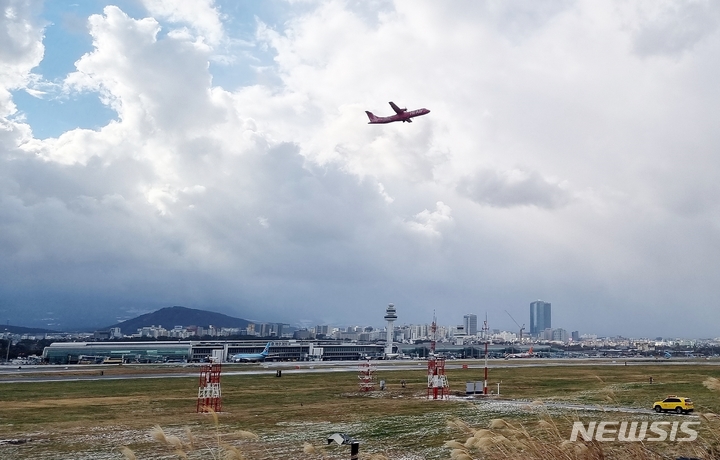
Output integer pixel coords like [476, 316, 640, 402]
[570, 422, 700, 442]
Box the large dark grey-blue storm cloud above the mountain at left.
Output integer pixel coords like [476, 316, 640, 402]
[0, 136, 404, 325]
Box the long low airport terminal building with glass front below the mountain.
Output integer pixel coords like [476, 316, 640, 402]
[43, 340, 394, 364]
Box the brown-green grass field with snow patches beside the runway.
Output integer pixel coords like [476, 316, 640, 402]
[0, 363, 720, 459]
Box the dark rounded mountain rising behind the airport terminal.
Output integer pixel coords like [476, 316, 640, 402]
[103, 307, 250, 334]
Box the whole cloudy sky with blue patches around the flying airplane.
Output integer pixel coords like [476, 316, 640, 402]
[0, 0, 720, 338]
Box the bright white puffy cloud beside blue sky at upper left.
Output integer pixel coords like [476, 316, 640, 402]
[66, 6, 224, 135]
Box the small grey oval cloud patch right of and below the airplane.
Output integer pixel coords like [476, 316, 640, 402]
[458, 169, 570, 209]
